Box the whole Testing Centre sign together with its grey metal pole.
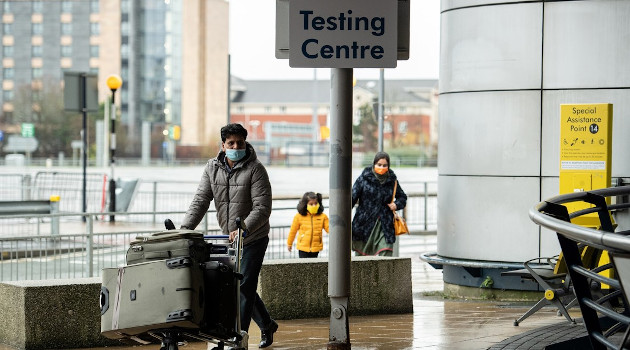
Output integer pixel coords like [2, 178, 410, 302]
[276, 0, 409, 350]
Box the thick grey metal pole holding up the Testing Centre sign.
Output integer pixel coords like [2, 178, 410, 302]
[327, 68, 352, 350]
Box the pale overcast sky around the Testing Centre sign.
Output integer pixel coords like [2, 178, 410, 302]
[229, 0, 440, 80]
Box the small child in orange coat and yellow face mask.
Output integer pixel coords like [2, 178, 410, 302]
[287, 192, 328, 258]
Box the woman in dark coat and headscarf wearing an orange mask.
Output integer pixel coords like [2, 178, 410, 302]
[352, 152, 407, 256]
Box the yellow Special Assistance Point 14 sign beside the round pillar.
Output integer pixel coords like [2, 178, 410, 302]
[560, 103, 613, 226]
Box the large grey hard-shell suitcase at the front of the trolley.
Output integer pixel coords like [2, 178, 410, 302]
[101, 257, 205, 339]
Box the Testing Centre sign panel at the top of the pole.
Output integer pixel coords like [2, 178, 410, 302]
[276, 0, 410, 68]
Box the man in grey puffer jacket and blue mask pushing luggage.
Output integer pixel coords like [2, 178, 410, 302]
[181, 124, 278, 348]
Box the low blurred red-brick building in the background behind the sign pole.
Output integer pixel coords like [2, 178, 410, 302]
[231, 78, 438, 154]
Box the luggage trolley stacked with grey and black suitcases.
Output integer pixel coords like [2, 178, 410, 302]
[100, 219, 248, 350]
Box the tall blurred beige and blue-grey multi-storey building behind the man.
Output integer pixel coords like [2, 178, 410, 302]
[0, 0, 229, 157]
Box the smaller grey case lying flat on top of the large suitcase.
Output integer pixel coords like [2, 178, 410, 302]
[127, 230, 208, 265]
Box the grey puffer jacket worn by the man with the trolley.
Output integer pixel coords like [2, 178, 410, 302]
[182, 143, 271, 244]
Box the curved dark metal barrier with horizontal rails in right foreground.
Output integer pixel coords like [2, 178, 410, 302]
[529, 186, 630, 350]
